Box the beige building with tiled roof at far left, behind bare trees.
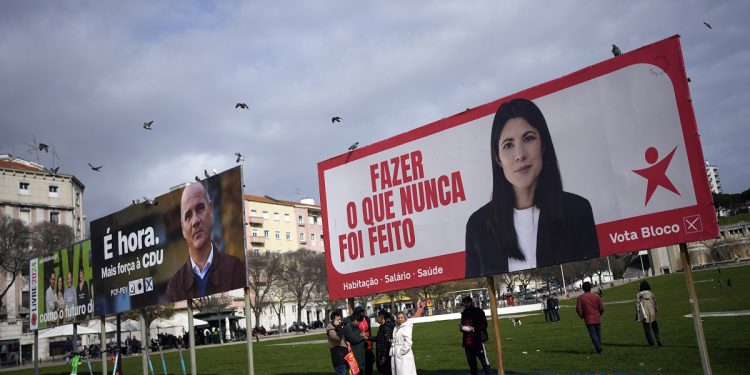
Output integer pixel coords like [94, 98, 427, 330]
[0, 155, 85, 367]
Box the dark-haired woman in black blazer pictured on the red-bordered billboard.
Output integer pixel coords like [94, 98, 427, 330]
[466, 99, 599, 278]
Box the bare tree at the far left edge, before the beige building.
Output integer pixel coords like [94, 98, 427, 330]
[0, 215, 35, 318]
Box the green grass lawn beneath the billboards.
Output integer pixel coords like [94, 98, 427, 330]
[3, 266, 750, 375]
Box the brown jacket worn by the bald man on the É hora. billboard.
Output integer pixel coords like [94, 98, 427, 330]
[166, 247, 247, 302]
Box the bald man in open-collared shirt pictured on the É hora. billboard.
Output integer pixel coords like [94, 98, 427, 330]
[167, 183, 246, 302]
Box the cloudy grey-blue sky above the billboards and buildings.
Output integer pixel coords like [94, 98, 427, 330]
[0, 0, 750, 226]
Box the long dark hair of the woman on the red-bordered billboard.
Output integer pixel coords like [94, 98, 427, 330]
[487, 99, 564, 261]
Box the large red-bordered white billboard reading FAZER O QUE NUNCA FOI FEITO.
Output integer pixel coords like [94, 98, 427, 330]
[318, 36, 718, 299]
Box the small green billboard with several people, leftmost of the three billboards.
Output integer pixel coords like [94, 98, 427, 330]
[29, 240, 94, 330]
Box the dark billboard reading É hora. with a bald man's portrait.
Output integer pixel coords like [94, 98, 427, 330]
[91, 167, 247, 316]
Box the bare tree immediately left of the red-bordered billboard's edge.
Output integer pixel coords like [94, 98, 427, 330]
[283, 249, 326, 322]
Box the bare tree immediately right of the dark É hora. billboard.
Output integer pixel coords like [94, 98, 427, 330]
[246, 253, 284, 329]
